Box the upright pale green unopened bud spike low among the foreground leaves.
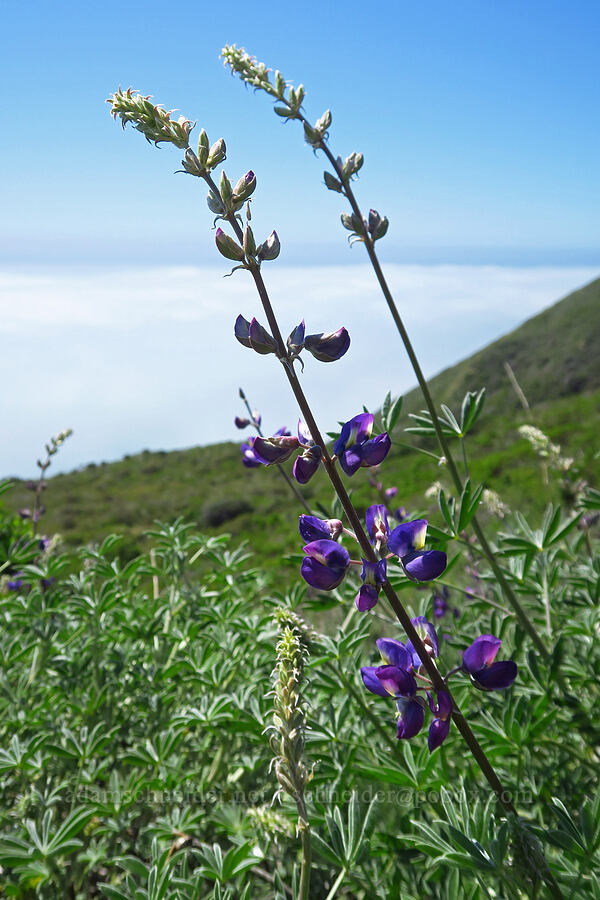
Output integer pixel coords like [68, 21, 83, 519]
[270, 624, 311, 804]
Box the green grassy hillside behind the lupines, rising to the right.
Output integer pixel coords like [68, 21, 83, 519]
[7, 280, 600, 565]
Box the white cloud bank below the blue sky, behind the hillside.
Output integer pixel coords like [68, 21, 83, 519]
[0, 263, 598, 476]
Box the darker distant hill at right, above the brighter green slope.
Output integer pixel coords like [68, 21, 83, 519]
[404, 278, 600, 412]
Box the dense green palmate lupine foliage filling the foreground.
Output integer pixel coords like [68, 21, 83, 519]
[0, 478, 600, 900]
